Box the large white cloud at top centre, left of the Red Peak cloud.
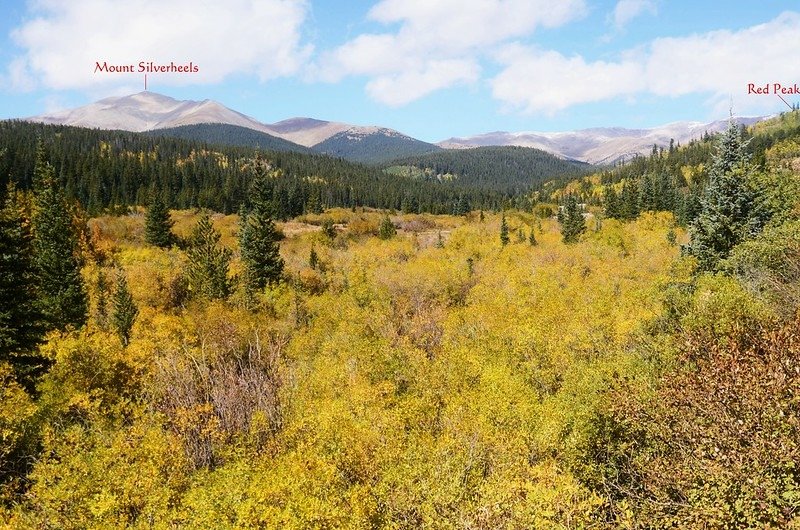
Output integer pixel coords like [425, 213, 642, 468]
[312, 0, 586, 105]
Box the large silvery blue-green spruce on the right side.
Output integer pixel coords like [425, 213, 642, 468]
[686, 120, 767, 270]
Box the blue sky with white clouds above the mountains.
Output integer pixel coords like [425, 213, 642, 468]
[0, 0, 800, 141]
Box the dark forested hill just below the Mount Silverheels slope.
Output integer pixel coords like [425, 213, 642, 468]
[144, 123, 314, 153]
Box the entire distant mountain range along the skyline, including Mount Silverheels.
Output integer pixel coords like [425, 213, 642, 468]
[27, 92, 765, 164]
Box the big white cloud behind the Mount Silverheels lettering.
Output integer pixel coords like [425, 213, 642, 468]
[8, 0, 311, 90]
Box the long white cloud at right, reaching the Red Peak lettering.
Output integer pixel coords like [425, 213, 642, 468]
[491, 13, 800, 113]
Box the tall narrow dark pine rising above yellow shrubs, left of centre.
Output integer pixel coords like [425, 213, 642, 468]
[239, 162, 283, 293]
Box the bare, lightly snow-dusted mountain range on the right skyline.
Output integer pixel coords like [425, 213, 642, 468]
[437, 117, 766, 164]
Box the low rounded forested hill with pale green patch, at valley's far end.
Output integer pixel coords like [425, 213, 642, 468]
[389, 147, 590, 193]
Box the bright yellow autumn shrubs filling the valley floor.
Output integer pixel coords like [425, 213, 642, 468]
[6, 210, 678, 529]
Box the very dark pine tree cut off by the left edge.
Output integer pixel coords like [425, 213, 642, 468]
[0, 186, 47, 387]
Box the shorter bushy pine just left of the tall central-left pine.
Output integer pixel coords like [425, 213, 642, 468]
[186, 214, 231, 300]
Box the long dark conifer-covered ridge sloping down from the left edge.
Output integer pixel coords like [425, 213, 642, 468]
[0, 121, 506, 217]
